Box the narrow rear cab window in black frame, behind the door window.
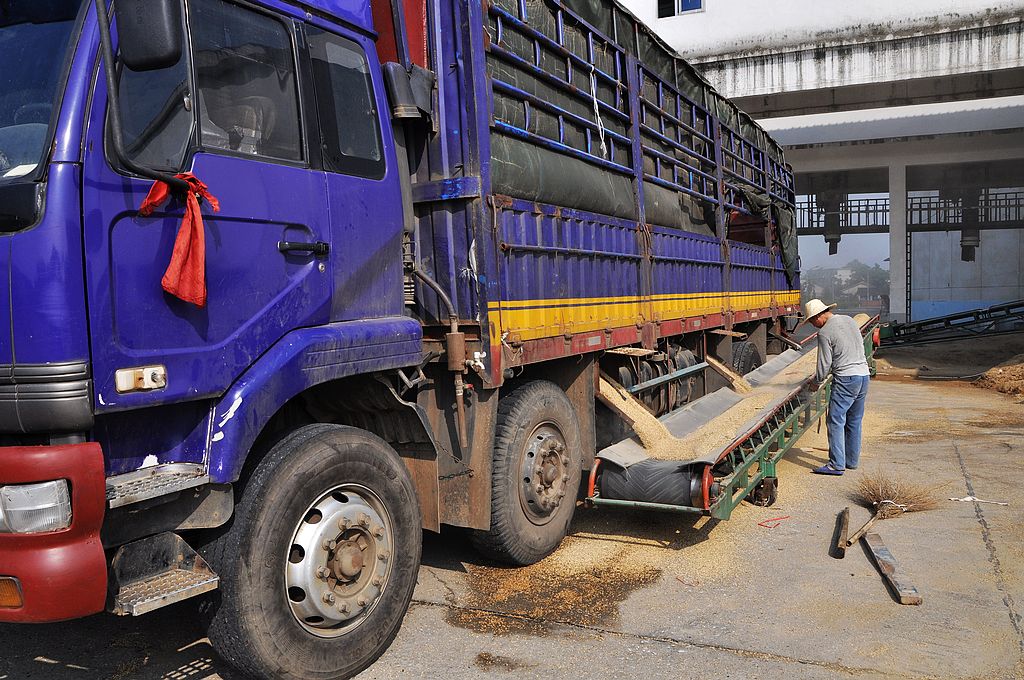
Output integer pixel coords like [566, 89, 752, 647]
[307, 27, 384, 178]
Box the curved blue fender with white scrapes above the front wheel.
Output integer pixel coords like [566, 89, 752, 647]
[209, 316, 423, 483]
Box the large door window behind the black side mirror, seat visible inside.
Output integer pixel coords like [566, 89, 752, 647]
[189, 0, 302, 161]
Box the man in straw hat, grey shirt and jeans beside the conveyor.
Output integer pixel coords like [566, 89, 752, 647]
[804, 299, 870, 475]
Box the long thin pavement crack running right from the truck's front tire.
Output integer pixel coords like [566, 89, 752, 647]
[413, 599, 935, 680]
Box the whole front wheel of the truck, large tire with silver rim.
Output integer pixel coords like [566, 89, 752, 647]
[203, 424, 423, 679]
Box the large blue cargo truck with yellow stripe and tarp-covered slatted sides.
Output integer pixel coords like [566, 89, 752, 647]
[0, 0, 800, 678]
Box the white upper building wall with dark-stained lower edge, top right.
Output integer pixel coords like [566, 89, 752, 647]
[620, 0, 1024, 58]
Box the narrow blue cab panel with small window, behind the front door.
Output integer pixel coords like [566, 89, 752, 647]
[306, 26, 406, 321]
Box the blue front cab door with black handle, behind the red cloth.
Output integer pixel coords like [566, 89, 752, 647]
[83, 0, 332, 412]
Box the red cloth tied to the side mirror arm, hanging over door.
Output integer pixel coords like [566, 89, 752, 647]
[138, 172, 220, 307]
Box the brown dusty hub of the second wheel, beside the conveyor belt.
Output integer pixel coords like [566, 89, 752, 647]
[519, 424, 569, 524]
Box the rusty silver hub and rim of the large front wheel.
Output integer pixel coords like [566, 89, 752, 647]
[285, 484, 394, 637]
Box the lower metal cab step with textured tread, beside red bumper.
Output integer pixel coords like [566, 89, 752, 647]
[108, 532, 220, 617]
